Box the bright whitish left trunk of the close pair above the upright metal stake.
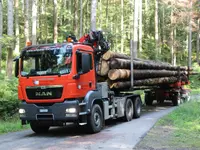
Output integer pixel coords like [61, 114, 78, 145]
[133, 0, 139, 58]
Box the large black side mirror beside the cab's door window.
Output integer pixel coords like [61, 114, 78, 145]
[82, 53, 91, 74]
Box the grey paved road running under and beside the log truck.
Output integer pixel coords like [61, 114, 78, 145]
[0, 103, 176, 150]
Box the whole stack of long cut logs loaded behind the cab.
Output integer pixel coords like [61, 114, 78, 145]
[97, 51, 187, 89]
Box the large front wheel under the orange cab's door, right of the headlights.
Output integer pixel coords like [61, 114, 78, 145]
[88, 104, 103, 133]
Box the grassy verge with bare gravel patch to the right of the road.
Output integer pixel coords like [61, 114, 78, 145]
[135, 100, 200, 150]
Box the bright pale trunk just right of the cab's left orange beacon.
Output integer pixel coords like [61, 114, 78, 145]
[32, 0, 37, 45]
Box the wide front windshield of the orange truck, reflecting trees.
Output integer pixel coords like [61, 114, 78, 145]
[21, 46, 72, 76]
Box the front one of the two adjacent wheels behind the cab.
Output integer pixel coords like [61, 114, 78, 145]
[123, 98, 134, 121]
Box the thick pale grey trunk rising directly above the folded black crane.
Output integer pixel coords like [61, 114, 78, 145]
[91, 0, 97, 31]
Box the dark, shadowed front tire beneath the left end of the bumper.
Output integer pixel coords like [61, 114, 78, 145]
[30, 121, 50, 134]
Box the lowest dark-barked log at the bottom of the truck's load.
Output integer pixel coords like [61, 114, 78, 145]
[110, 77, 178, 89]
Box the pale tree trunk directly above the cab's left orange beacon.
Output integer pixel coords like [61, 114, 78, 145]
[24, 0, 30, 45]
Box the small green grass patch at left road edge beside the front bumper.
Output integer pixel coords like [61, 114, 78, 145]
[0, 115, 29, 134]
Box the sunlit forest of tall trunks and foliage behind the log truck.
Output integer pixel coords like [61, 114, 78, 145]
[0, 0, 200, 119]
